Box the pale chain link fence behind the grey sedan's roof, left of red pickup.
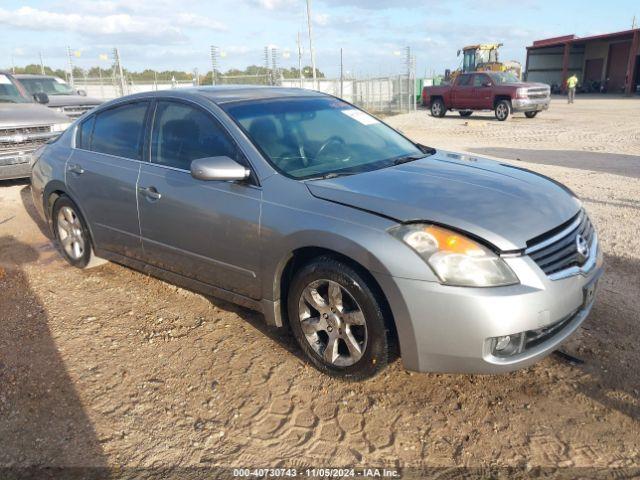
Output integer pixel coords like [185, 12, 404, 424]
[75, 74, 420, 115]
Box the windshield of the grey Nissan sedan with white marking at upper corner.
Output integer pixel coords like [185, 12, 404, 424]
[223, 97, 425, 179]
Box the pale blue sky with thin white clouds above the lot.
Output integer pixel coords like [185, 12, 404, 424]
[0, 0, 640, 77]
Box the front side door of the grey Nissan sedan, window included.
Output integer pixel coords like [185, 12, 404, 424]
[138, 101, 262, 298]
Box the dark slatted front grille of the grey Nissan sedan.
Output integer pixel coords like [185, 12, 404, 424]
[525, 211, 594, 275]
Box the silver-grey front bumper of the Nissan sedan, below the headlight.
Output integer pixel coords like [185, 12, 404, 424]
[376, 238, 603, 374]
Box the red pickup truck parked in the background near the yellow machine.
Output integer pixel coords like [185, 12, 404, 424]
[422, 72, 551, 121]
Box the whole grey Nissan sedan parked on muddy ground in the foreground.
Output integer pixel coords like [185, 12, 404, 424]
[32, 87, 602, 379]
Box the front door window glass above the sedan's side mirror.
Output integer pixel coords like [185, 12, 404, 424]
[151, 102, 237, 170]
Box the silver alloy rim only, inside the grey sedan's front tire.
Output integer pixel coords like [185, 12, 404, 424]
[298, 280, 367, 367]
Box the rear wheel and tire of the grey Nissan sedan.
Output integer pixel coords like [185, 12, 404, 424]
[51, 195, 106, 268]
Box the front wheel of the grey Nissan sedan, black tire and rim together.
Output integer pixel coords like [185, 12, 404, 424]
[287, 256, 389, 380]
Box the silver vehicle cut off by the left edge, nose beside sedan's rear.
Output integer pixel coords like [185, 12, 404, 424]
[0, 72, 70, 180]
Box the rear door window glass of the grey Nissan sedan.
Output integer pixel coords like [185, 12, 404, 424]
[90, 102, 149, 160]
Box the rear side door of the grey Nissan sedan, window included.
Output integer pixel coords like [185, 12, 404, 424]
[66, 101, 150, 258]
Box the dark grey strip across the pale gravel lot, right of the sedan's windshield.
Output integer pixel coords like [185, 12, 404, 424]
[469, 148, 640, 178]
